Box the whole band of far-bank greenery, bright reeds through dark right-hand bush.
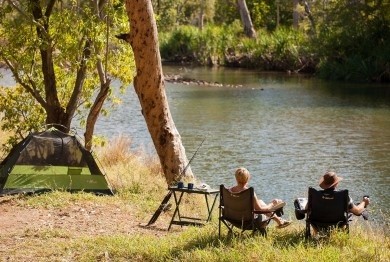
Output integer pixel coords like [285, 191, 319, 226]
[160, 5, 390, 82]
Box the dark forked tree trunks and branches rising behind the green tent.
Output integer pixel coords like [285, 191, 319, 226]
[4, 0, 111, 150]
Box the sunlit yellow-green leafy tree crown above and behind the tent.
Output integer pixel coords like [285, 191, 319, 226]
[0, 0, 134, 149]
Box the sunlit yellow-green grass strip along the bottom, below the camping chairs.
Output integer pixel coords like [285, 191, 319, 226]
[8, 222, 390, 262]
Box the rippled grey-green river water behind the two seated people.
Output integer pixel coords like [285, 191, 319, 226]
[0, 67, 390, 218]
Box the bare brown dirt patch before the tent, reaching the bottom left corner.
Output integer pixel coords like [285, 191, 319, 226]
[0, 196, 174, 261]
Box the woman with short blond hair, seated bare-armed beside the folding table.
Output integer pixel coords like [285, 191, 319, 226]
[229, 167, 291, 228]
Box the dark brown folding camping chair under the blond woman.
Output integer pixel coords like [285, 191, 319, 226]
[218, 185, 281, 238]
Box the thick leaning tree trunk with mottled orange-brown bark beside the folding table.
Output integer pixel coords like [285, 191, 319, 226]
[126, 0, 193, 184]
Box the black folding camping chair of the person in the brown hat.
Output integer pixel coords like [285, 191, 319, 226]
[305, 187, 349, 239]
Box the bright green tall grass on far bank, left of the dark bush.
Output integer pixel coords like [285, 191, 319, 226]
[160, 22, 314, 71]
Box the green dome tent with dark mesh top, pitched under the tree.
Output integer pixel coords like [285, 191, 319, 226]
[0, 128, 113, 195]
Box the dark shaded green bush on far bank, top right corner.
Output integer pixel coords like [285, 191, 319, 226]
[313, 1, 390, 82]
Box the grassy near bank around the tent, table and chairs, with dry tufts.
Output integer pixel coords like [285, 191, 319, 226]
[0, 137, 390, 261]
